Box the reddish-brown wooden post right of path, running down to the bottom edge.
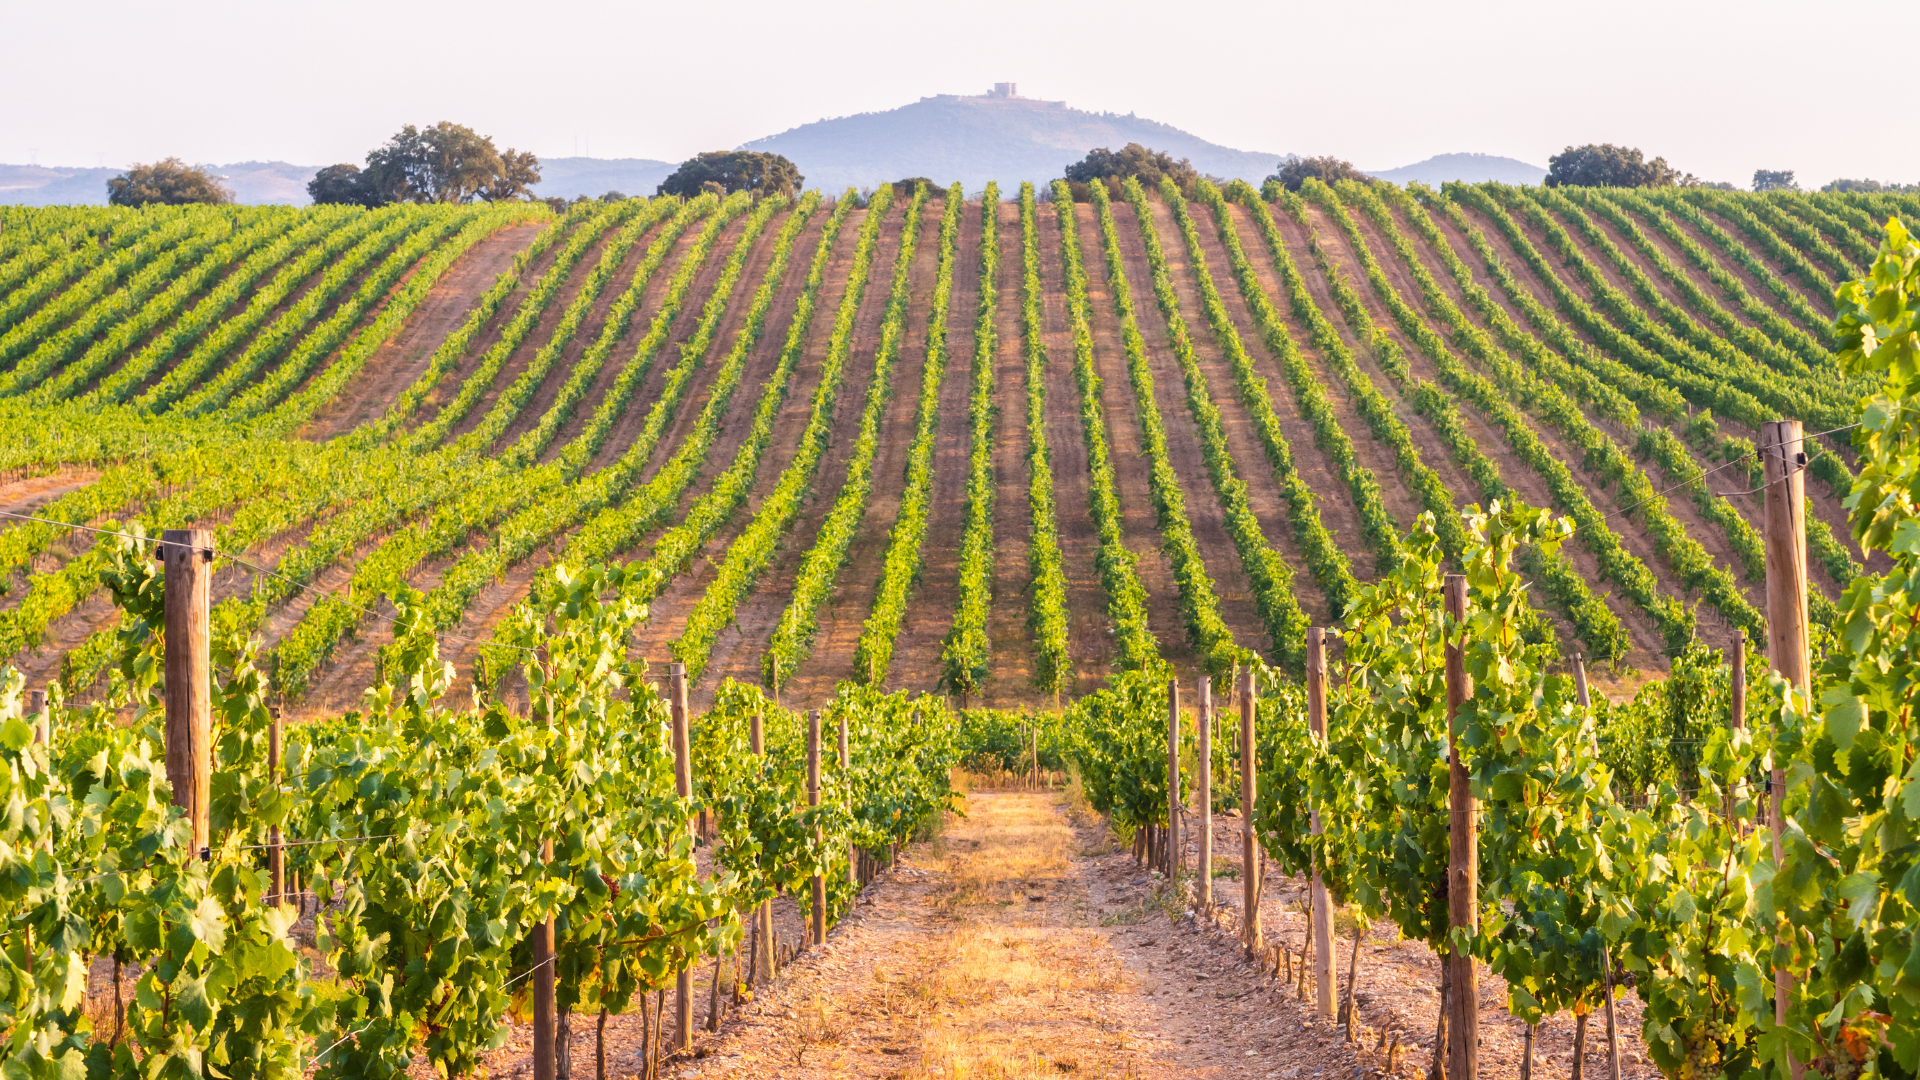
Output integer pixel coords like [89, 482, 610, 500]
[1446, 575, 1480, 1080]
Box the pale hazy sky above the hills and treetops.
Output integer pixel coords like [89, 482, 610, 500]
[0, 0, 1920, 186]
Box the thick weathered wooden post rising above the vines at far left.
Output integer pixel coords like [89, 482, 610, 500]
[159, 528, 213, 859]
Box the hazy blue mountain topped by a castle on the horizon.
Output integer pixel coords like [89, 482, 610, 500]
[741, 83, 1281, 192]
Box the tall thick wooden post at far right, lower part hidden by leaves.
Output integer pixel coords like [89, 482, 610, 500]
[1761, 421, 1812, 1045]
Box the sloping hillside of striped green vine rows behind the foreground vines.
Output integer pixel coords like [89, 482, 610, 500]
[0, 181, 1889, 715]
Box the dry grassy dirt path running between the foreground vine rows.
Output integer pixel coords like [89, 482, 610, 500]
[468, 780, 1651, 1080]
